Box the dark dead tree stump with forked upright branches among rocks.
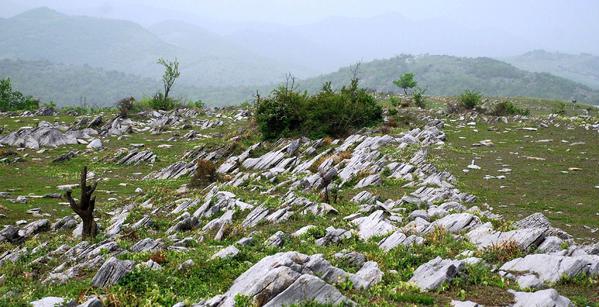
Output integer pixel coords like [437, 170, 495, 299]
[65, 166, 98, 239]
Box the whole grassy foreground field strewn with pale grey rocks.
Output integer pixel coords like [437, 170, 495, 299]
[0, 100, 599, 306]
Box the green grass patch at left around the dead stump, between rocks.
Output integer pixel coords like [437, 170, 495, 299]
[0, 114, 258, 224]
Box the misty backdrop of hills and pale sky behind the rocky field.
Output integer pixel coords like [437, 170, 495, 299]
[0, 0, 599, 104]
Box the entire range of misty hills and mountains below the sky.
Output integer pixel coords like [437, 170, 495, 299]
[0, 8, 599, 105]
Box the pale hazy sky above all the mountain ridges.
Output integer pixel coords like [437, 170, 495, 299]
[0, 0, 599, 53]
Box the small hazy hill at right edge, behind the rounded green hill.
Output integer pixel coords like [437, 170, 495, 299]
[502, 50, 599, 89]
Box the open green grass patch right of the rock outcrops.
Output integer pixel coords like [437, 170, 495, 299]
[433, 121, 599, 240]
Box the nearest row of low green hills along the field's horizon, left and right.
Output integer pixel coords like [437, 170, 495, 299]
[0, 55, 599, 105]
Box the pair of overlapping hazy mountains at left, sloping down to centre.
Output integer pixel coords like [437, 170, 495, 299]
[0, 8, 298, 86]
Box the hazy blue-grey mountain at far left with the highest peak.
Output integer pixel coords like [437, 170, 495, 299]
[0, 8, 175, 78]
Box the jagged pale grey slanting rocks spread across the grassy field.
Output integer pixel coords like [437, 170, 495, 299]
[0, 109, 599, 306]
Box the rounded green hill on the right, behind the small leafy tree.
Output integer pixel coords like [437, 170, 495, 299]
[300, 55, 599, 104]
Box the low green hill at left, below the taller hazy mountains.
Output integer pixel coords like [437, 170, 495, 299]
[0, 59, 256, 106]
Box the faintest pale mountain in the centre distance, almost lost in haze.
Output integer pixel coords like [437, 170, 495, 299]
[226, 13, 532, 73]
